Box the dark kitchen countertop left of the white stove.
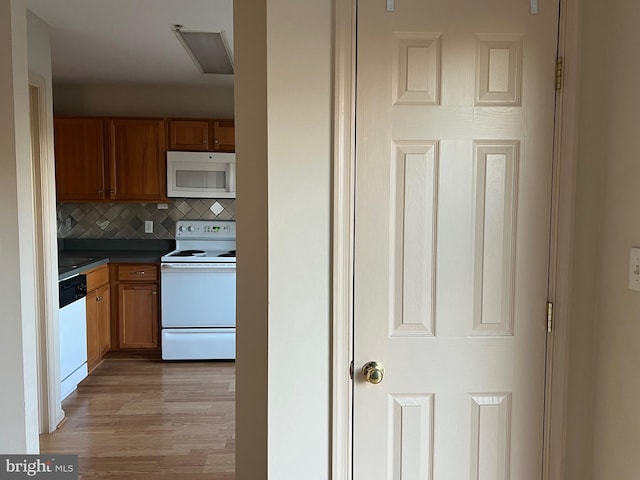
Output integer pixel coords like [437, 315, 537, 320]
[58, 238, 175, 280]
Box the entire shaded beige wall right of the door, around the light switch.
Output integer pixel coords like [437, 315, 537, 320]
[566, 0, 640, 480]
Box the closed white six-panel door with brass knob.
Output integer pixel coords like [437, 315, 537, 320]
[353, 0, 558, 480]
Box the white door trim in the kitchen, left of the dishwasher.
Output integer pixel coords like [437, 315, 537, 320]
[29, 72, 64, 433]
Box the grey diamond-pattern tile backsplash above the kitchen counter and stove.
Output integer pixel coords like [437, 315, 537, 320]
[57, 198, 236, 239]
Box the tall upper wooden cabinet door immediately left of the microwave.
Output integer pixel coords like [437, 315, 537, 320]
[109, 119, 167, 201]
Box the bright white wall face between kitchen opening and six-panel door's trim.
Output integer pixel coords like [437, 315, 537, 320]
[267, 0, 333, 474]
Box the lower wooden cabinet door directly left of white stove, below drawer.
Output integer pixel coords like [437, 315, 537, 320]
[118, 283, 159, 348]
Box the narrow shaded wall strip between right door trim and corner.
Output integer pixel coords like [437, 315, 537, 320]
[565, 0, 607, 480]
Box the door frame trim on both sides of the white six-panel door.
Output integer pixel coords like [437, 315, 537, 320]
[331, 0, 582, 480]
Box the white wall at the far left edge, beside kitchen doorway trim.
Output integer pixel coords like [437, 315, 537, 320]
[0, 0, 39, 453]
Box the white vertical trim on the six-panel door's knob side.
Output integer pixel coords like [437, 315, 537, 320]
[331, 0, 356, 480]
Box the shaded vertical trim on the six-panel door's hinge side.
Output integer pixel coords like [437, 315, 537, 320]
[544, 0, 582, 480]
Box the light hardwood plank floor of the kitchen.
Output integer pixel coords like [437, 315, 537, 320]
[40, 358, 235, 480]
